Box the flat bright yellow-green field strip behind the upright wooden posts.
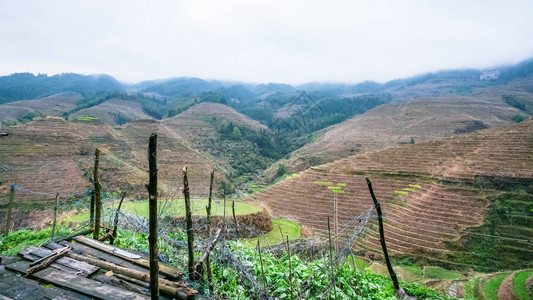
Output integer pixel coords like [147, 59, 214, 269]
[63, 199, 261, 223]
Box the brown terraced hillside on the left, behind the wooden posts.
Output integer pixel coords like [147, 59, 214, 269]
[0, 118, 223, 228]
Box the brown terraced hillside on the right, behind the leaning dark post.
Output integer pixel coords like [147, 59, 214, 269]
[253, 120, 533, 269]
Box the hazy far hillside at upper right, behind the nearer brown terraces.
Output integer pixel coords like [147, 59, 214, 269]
[266, 77, 533, 176]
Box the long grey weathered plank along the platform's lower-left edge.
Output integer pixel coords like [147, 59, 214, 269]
[6, 261, 149, 300]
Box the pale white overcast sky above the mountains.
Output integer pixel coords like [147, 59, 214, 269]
[0, 0, 533, 84]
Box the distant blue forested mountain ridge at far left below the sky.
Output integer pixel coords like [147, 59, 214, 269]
[0, 73, 124, 104]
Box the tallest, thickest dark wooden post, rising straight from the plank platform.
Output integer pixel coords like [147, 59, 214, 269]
[148, 133, 159, 299]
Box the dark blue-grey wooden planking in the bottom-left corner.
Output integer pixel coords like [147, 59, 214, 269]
[0, 266, 91, 300]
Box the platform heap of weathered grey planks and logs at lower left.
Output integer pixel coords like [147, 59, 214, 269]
[6, 236, 198, 299]
